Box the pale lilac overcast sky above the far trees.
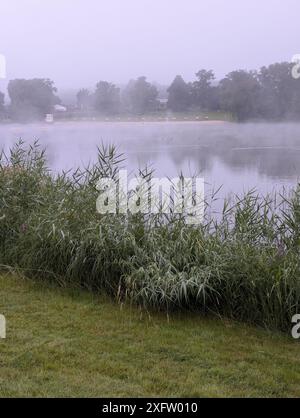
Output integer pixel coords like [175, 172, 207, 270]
[0, 0, 300, 89]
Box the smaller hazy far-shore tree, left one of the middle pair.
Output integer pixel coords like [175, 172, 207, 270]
[94, 81, 120, 115]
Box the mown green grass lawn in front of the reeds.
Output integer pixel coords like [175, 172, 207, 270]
[0, 275, 300, 397]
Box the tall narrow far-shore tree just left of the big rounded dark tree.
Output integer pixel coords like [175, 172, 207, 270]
[191, 70, 218, 110]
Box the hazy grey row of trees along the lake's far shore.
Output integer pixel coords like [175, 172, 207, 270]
[0, 62, 300, 121]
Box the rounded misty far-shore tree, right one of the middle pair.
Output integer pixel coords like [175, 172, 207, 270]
[122, 77, 158, 115]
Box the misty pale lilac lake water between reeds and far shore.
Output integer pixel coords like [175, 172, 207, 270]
[0, 122, 300, 205]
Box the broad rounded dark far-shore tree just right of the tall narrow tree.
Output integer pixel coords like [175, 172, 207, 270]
[219, 70, 261, 121]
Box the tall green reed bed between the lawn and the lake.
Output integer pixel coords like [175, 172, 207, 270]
[0, 142, 300, 331]
